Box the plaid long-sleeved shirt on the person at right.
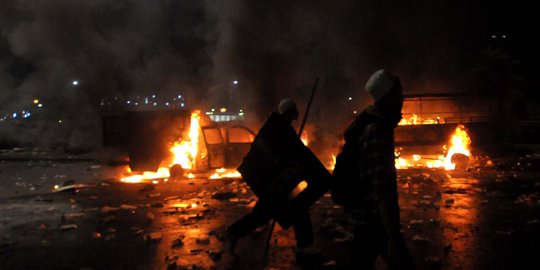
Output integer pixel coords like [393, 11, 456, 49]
[346, 108, 399, 231]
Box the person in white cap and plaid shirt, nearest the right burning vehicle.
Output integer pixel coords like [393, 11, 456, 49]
[332, 69, 415, 269]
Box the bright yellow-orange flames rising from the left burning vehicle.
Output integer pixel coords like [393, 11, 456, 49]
[120, 110, 240, 184]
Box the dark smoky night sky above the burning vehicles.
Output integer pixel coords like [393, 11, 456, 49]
[0, 0, 539, 148]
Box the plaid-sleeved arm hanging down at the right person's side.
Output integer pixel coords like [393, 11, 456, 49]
[365, 124, 400, 238]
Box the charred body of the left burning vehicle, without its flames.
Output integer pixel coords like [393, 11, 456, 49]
[102, 110, 255, 171]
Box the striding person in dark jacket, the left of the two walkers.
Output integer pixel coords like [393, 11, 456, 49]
[224, 99, 331, 265]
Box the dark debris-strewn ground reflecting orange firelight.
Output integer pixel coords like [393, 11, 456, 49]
[0, 149, 540, 270]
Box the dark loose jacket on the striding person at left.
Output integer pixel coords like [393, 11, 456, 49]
[238, 112, 330, 225]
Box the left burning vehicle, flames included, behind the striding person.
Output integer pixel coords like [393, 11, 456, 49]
[102, 110, 255, 181]
